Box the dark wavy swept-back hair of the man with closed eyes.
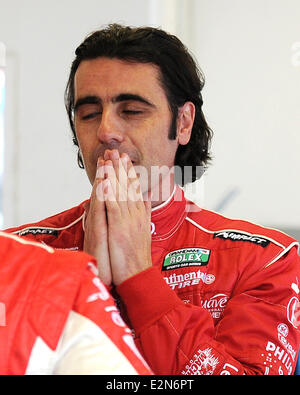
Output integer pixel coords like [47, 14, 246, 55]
[65, 24, 212, 185]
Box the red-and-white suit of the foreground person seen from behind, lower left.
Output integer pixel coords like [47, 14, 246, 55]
[0, 232, 150, 375]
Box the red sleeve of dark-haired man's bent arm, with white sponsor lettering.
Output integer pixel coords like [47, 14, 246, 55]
[118, 248, 300, 375]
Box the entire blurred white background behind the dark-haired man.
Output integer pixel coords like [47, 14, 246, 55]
[0, 0, 300, 237]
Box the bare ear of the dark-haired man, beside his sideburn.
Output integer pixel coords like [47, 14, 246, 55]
[177, 102, 195, 145]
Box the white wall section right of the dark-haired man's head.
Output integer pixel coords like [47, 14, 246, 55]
[193, 0, 300, 229]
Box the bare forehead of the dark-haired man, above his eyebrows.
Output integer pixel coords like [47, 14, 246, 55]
[74, 57, 167, 100]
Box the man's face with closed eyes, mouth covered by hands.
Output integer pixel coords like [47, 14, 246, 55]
[75, 57, 178, 196]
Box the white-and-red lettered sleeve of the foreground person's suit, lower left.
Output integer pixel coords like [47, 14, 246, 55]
[26, 263, 151, 375]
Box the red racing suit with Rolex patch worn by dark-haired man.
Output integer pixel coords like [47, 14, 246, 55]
[9, 187, 300, 375]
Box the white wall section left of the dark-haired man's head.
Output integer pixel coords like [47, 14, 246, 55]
[0, 0, 154, 226]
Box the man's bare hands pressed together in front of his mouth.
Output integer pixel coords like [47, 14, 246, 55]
[84, 150, 152, 286]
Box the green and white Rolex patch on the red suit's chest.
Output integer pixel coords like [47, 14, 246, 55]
[162, 247, 210, 270]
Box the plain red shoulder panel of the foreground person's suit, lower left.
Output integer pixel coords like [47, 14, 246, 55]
[0, 232, 92, 374]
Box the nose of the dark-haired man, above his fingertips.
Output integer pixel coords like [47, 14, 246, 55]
[97, 109, 124, 145]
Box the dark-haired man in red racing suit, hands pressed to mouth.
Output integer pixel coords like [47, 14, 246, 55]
[4, 25, 300, 374]
